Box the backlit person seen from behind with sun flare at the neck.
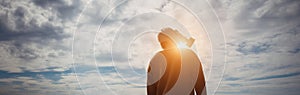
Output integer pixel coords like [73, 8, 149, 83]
[147, 28, 206, 95]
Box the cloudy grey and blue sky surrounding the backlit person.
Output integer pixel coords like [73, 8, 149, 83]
[0, 0, 300, 95]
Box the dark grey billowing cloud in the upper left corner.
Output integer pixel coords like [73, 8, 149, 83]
[0, 6, 67, 42]
